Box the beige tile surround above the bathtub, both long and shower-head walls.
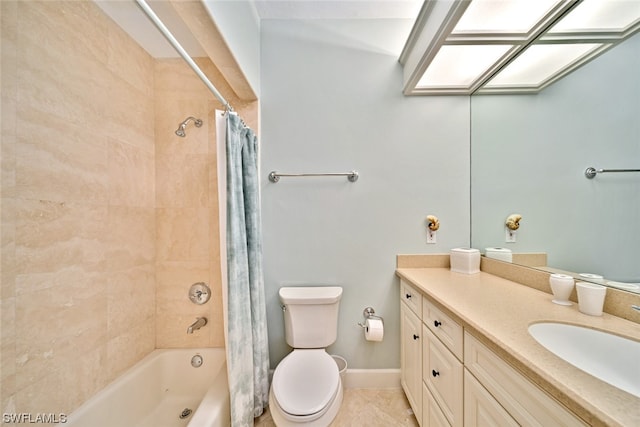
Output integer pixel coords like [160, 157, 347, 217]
[0, 0, 257, 422]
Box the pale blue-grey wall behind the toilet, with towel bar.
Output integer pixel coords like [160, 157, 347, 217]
[260, 20, 470, 368]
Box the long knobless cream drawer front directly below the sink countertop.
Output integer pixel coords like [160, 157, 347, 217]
[464, 332, 586, 427]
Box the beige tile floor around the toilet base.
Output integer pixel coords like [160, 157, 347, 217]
[254, 388, 418, 427]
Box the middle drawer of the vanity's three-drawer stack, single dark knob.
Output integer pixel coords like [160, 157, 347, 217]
[422, 325, 463, 427]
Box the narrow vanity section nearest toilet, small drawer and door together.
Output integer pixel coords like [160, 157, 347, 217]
[400, 281, 422, 420]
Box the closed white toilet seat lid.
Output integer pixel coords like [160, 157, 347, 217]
[272, 349, 340, 422]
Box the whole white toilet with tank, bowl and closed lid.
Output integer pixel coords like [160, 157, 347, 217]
[269, 286, 343, 427]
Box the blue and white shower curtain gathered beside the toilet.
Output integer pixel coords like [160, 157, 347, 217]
[217, 112, 269, 427]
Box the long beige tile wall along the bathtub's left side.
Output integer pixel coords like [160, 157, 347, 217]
[0, 1, 156, 413]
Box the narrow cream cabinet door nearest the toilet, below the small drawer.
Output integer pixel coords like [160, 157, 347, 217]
[400, 303, 422, 421]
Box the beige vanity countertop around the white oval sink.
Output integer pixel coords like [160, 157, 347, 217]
[396, 268, 640, 426]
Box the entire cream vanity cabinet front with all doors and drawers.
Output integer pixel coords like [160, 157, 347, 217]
[400, 280, 587, 427]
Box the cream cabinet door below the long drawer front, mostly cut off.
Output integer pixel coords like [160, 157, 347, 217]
[464, 369, 518, 427]
